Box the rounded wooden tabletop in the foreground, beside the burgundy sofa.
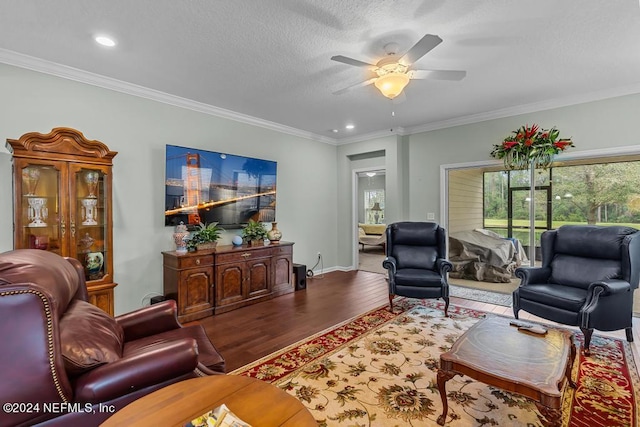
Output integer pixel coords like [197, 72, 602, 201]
[101, 375, 318, 427]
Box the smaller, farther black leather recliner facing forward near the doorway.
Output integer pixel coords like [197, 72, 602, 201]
[382, 222, 453, 316]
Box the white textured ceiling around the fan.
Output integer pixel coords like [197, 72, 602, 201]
[0, 0, 640, 143]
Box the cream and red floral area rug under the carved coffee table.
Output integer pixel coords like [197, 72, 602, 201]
[231, 299, 640, 427]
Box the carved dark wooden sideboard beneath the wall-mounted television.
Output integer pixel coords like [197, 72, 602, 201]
[162, 242, 294, 322]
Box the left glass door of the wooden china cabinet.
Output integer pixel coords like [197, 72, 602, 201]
[15, 162, 64, 255]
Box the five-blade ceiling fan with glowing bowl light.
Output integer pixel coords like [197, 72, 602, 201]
[331, 34, 467, 99]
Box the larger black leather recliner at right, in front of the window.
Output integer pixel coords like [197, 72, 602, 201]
[513, 225, 640, 355]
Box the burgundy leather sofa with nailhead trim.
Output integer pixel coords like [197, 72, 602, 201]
[0, 249, 224, 426]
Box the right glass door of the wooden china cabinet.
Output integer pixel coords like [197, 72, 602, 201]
[70, 164, 112, 281]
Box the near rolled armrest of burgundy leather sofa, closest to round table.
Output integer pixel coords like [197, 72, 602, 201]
[74, 338, 198, 403]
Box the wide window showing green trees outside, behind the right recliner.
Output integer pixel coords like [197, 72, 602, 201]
[484, 159, 640, 246]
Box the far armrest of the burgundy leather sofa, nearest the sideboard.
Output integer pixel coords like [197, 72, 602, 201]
[115, 300, 182, 342]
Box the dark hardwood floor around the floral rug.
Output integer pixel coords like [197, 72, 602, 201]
[191, 271, 640, 372]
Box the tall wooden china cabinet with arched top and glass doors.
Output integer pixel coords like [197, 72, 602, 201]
[7, 128, 117, 315]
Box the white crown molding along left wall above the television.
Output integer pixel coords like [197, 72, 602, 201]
[0, 48, 336, 145]
